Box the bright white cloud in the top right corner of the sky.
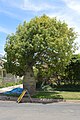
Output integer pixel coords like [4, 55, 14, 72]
[62, 0, 80, 14]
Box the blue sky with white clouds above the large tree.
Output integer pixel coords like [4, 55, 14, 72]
[0, 0, 80, 55]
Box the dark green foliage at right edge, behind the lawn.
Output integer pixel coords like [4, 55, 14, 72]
[64, 54, 80, 84]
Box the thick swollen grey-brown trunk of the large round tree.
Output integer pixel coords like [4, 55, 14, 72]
[23, 67, 36, 94]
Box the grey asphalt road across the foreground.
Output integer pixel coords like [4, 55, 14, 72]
[0, 101, 80, 120]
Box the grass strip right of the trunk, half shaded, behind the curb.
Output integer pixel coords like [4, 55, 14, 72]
[33, 91, 80, 100]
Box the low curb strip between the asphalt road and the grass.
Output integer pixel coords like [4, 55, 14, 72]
[0, 94, 80, 104]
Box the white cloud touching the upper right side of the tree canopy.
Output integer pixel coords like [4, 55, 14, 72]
[47, 7, 80, 33]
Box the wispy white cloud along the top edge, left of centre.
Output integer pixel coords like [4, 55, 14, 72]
[1, 0, 54, 12]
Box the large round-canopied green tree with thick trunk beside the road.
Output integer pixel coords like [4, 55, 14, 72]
[5, 15, 76, 92]
